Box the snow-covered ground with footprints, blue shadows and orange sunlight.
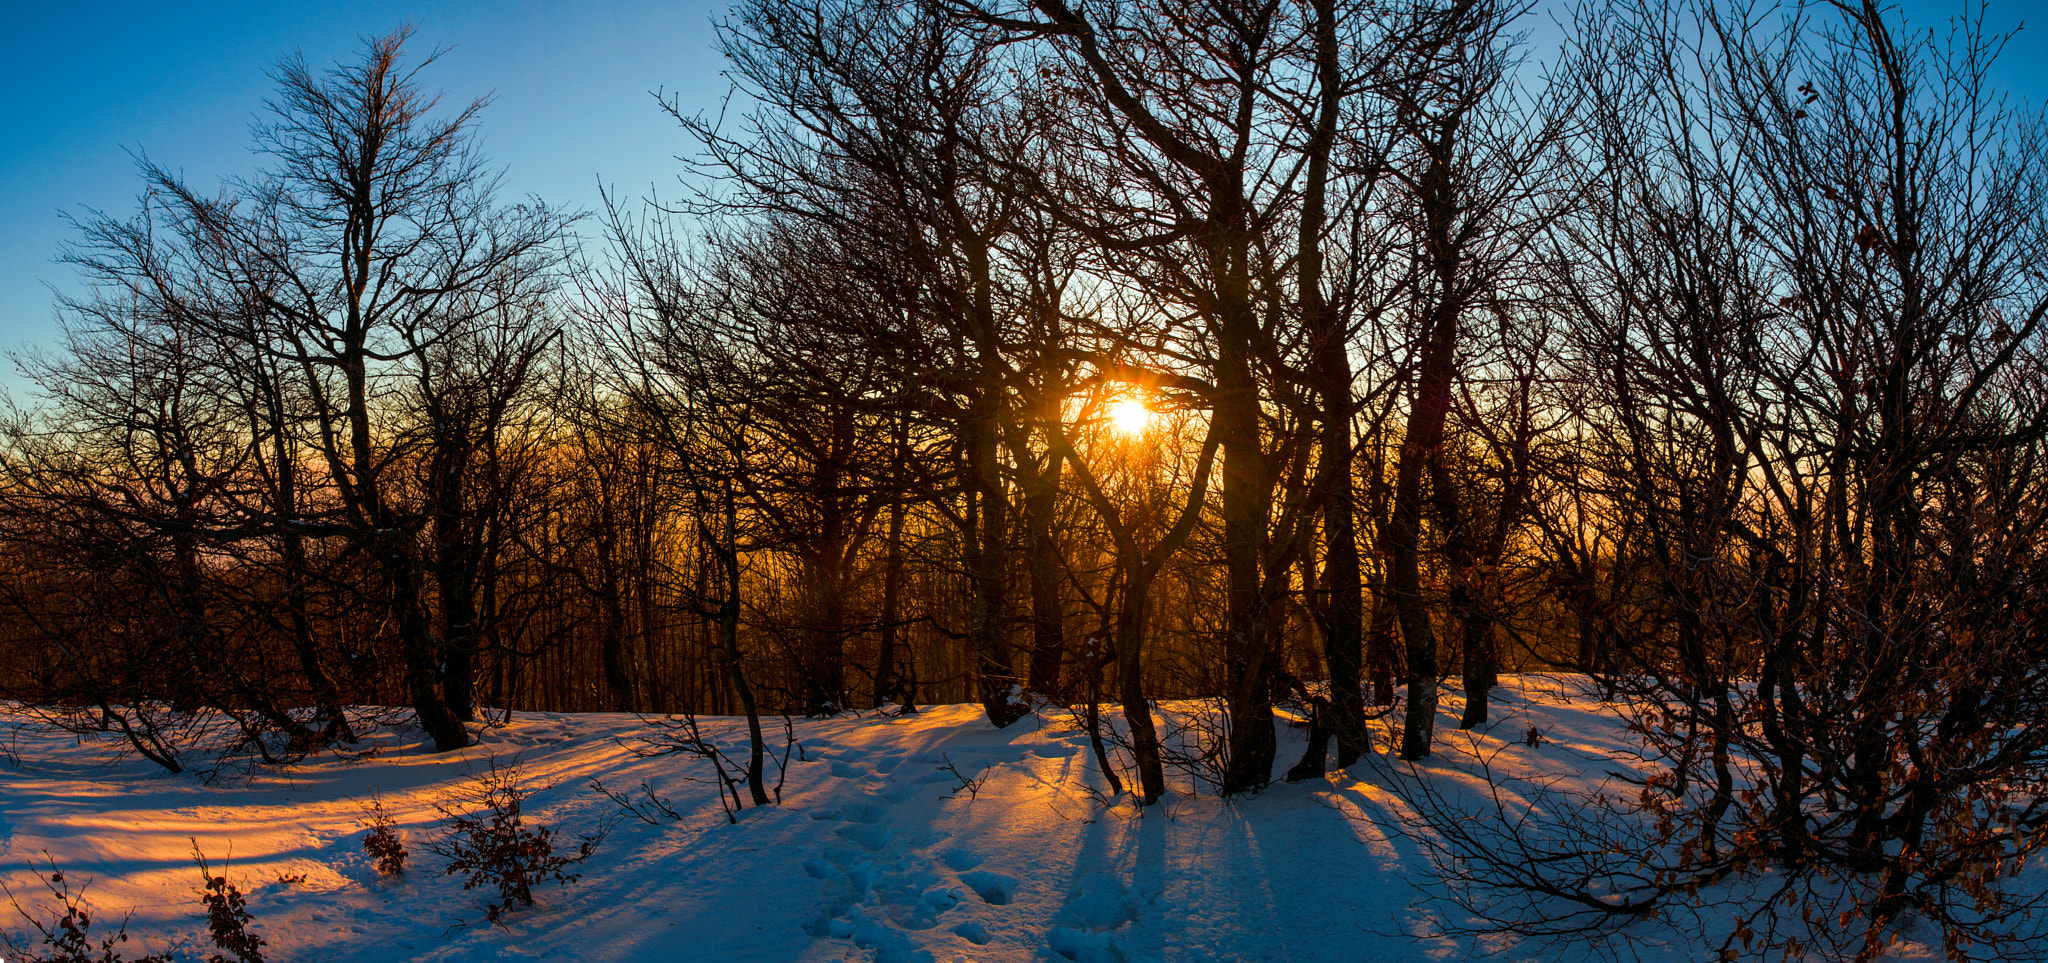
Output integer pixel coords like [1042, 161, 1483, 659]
[0, 676, 1998, 963]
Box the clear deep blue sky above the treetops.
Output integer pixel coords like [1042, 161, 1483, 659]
[0, 0, 2048, 368]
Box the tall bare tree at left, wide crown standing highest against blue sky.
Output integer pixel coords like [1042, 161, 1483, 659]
[36, 29, 565, 750]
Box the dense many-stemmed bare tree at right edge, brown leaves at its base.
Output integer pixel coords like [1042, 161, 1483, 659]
[1417, 2, 2048, 959]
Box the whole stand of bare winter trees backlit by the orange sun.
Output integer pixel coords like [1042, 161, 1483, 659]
[0, 0, 2048, 959]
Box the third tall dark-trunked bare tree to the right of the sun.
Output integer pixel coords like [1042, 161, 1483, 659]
[1382, 2, 1563, 760]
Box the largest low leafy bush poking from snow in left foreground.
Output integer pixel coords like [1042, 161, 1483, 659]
[426, 760, 606, 922]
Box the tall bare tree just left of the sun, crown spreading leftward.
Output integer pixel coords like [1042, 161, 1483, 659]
[684, 0, 1057, 725]
